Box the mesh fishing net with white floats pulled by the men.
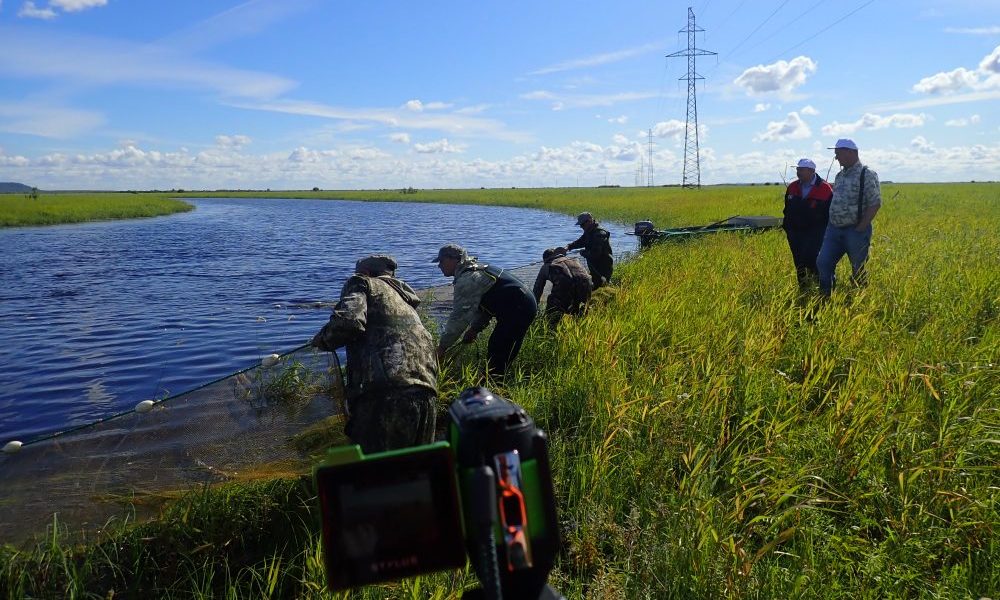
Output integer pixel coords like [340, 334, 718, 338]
[0, 263, 538, 543]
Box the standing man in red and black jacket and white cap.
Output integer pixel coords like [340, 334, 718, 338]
[782, 158, 833, 290]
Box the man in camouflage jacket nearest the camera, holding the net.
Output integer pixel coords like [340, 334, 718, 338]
[312, 254, 438, 454]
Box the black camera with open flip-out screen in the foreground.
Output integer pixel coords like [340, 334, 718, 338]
[313, 388, 560, 599]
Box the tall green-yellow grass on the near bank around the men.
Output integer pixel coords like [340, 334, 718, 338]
[0, 184, 1000, 599]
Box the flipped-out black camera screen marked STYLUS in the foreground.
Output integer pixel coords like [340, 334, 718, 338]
[316, 444, 465, 589]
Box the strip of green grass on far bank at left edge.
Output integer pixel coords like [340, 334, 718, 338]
[0, 192, 194, 227]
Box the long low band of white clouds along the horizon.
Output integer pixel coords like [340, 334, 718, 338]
[11, 138, 1000, 189]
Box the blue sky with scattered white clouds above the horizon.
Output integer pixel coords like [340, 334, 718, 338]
[0, 0, 1000, 190]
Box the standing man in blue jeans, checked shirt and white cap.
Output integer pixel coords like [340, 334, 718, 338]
[816, 138, 882, 296]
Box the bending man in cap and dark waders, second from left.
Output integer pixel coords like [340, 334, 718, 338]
[434, 244, 538, 377]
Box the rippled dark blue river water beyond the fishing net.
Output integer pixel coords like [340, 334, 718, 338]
[0, 199, 634, 445]
